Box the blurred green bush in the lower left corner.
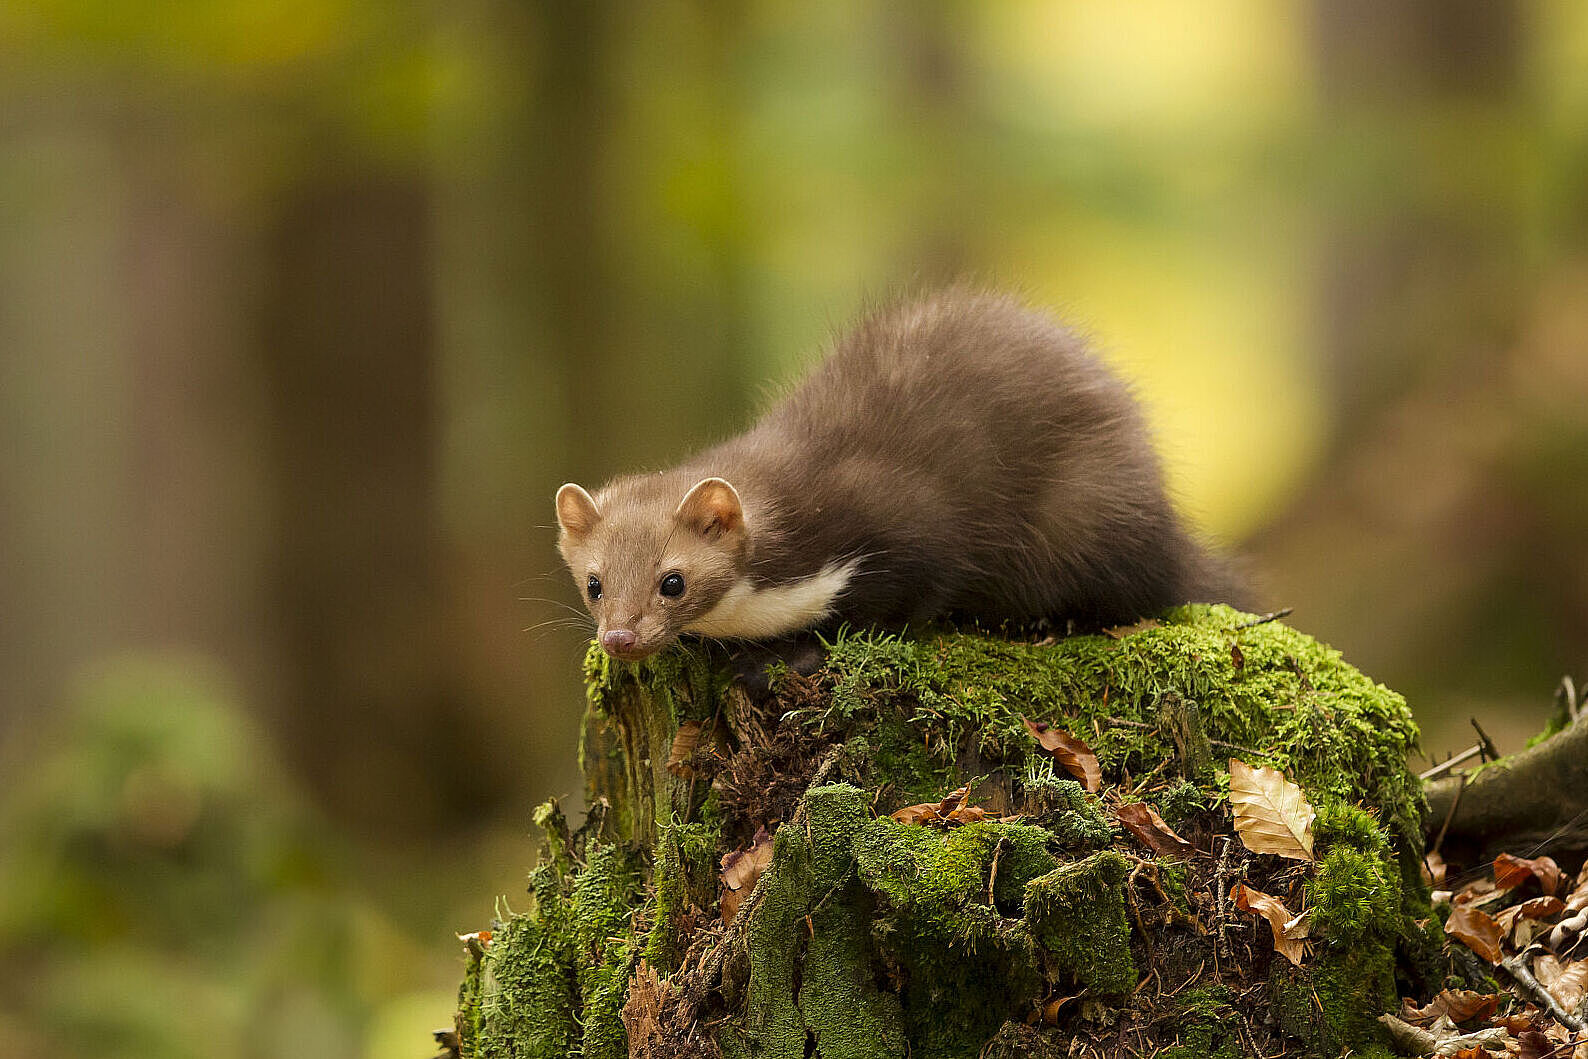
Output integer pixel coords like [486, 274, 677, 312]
[0, 657, 397, 1059]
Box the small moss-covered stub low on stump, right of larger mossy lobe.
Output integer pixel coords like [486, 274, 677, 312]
[1026, 851, 1135, 997]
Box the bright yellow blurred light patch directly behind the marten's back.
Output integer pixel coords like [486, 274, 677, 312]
[1021, 222, 1328, 540]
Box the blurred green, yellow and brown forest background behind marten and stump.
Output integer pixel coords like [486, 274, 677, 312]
[0, 0, 1588, 1059]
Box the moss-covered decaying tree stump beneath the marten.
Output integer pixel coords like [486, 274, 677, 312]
[454, 607, 1450, 1059]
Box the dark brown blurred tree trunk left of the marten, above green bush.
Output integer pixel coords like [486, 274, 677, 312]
[260, 171, 484, 834]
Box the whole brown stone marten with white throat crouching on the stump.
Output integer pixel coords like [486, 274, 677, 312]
[556, 289, 1226, 660]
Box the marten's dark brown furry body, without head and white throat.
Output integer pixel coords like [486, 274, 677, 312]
[692, 291, 1212, 622]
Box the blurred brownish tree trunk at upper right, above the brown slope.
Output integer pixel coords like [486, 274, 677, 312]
[1315, 0, 1523, 431]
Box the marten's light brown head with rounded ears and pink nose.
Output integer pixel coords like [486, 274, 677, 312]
[557, 475, 748, 660]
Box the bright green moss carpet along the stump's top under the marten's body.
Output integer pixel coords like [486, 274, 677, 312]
[800, 605, 1423, 846]
